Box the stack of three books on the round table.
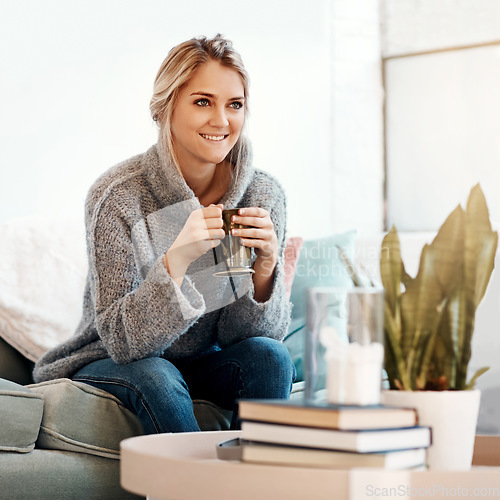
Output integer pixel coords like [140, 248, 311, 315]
[229, 400, 431, 469]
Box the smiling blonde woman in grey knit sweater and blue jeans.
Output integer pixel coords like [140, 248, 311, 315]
[34, 35, 295, 434]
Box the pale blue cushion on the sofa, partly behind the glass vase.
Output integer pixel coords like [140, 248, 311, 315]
[284, 231, 356, 381]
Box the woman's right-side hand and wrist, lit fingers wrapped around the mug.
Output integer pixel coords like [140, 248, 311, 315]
[231, 207, 278, 302]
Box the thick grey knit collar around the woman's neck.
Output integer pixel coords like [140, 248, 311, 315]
[146, 144, 254, 208]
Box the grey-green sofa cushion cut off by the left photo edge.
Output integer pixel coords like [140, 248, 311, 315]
[0, 379, 43, 453]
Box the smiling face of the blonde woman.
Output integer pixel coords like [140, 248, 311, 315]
[170, 61, 245, 172]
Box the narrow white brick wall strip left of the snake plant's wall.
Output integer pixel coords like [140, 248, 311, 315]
[330, 0, 384, 236]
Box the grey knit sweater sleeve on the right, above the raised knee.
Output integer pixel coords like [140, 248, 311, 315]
[218, 178, 290, 347]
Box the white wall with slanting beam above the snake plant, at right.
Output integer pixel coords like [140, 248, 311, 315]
[383, 0, 500, 231]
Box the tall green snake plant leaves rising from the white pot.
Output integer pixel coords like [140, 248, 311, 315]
[380, 184, 498, 390]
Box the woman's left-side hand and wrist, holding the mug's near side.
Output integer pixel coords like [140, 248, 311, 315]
[165, 205, 225, 286]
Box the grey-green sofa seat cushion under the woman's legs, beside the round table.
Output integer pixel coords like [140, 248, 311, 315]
[29, 379, 143, 459]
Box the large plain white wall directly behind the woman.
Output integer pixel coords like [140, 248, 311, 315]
[0, 0, 342, 240]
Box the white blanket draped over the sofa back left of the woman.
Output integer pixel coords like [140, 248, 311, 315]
[0, 216, 87, 361]
